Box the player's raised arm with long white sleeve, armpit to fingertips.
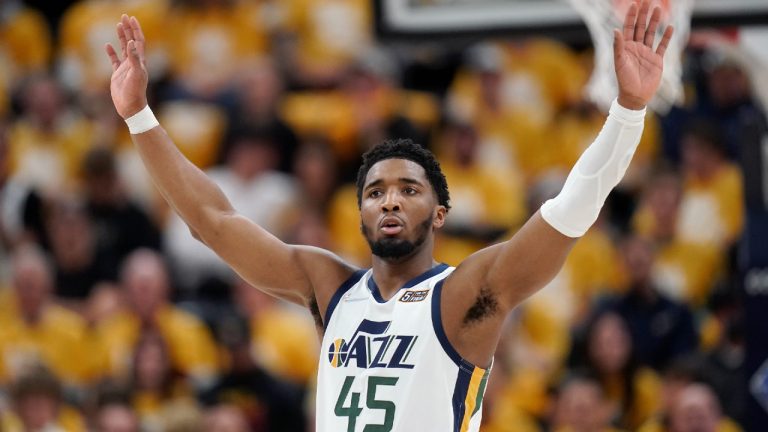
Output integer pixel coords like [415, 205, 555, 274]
[442, 0, 672, 368]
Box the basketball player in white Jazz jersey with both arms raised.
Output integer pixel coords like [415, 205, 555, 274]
[106, 0, 672, 432]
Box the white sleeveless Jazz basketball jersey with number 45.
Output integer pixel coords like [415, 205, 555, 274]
[317, 264, 490, 432]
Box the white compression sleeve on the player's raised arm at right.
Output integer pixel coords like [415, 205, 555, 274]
[541, 99, 645, 237]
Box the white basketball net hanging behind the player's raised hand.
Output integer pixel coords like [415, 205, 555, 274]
[568, 0, 693, 114]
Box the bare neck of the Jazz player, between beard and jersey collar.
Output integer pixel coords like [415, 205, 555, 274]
[373, 248, 437, 299]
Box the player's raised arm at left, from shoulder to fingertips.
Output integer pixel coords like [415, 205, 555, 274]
[106, 15, 354, 308]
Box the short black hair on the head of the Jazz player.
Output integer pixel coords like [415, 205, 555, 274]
[357, 138, 451, 210]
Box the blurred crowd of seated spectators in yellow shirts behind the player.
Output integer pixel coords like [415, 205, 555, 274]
[0, 0, 768, 432]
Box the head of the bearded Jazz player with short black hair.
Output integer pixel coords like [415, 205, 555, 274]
[357, 139, 451, 260]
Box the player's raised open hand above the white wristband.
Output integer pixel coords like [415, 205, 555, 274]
[105, 14, 149, 119]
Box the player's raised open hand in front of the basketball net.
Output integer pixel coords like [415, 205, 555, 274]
[613, 0, 673, 109]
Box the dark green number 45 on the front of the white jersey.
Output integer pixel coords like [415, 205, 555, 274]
[333, 376, 397, 432]
